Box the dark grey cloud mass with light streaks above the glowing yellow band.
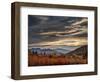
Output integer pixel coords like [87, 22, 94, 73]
[28, 15, 87, 43]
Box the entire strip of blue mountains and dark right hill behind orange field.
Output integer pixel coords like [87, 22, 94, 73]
[29, 45, 88, 57]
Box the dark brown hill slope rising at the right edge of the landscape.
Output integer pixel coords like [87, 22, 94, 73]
[67, 45, 88, 56]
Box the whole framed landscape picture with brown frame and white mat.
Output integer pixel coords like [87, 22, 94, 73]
[11, 2, 98, 80]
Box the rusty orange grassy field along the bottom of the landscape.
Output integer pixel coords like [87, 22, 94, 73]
[28, 53, 87, 66]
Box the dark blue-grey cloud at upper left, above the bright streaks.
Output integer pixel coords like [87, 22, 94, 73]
[28, 15, 82, 32]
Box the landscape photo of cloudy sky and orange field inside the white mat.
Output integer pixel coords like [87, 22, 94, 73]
[28, 15, 88, 66]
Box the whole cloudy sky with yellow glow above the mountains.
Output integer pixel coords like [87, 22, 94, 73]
[28, 15, 88, 46]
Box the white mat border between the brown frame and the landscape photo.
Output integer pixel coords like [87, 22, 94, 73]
[20, 7, 95, 75]
